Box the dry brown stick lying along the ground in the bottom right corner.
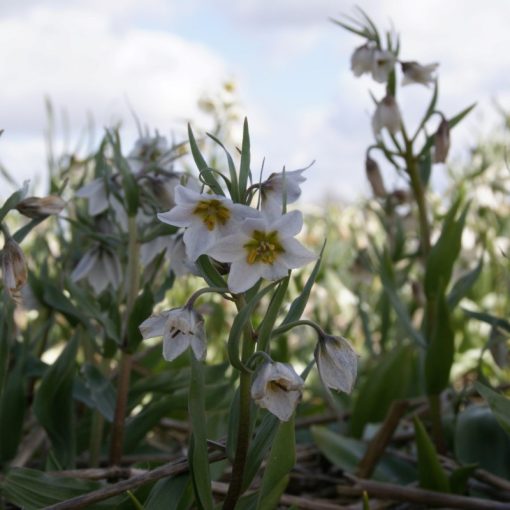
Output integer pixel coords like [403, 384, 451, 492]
[344, 473, 510, 510]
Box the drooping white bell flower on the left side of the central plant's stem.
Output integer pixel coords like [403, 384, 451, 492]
[139, 307, 207, 361]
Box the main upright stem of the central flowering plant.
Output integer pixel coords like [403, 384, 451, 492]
[223, 298, 255, 510]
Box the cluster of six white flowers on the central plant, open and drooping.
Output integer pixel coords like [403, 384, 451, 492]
[133, 152, 357, 421]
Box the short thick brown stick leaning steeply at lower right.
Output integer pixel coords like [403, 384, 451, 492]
[356, 400, 409, 478]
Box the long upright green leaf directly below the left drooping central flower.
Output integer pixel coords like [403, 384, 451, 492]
[188, 353, 214, 510]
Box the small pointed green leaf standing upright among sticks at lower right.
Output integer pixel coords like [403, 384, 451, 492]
[414, 416, 450, 492]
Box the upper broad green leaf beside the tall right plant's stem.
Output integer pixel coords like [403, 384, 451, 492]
[425, 198, 469, 300]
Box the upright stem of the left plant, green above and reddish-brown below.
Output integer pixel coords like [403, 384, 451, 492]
[110, 216, 140, 465]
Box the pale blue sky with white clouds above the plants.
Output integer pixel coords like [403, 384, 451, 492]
[0, 0, 510, 202]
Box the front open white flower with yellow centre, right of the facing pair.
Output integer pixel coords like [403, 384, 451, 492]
[208, 211, 316, 293]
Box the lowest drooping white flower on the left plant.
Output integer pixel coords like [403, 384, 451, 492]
[71, 246, 121, 295]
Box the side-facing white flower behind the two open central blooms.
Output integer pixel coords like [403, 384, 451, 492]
[260, 169, 306, 215]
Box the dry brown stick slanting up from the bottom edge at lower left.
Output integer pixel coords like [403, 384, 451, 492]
[39, 452, 225, 510]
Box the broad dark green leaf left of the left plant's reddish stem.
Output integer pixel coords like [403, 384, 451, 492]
[34, 335, 78, 468]
